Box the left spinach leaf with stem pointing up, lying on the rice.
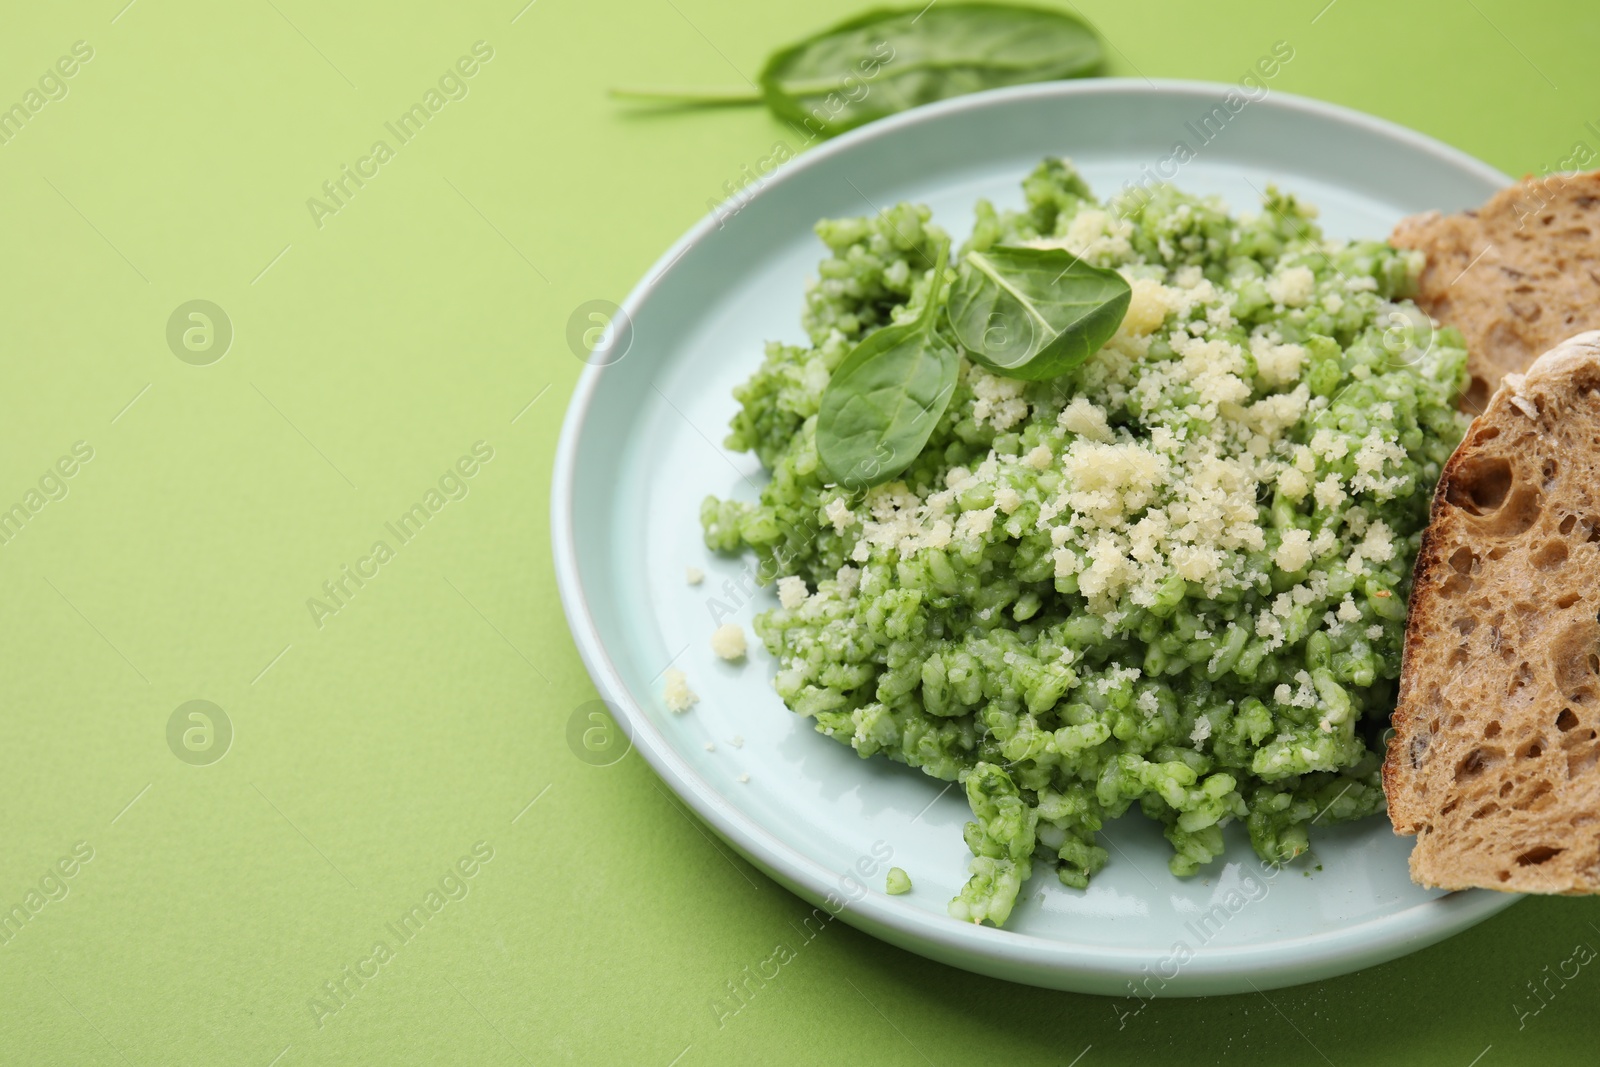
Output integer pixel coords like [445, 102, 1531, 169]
[816, 246, 962, 490]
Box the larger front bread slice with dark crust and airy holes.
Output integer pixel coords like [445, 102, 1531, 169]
[1384, 331, 1600, 893]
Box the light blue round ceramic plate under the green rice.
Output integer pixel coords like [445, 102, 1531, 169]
[552, 78, 1515, 1008]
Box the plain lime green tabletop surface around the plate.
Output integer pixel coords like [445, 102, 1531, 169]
[0, 0, 1600, 1067]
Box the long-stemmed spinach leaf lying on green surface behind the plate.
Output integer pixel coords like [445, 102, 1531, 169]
[611, 3, 1102, 139]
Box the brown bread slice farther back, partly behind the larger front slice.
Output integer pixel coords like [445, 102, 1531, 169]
[1389, 171, 1600, 414]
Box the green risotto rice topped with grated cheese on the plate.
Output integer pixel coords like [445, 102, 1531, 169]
[701, 160, 1466, 925]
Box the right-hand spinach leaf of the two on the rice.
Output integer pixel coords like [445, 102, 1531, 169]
[949, 245, 1133, 381]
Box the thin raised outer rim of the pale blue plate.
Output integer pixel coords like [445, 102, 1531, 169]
[550, 78, 1522, 997]
